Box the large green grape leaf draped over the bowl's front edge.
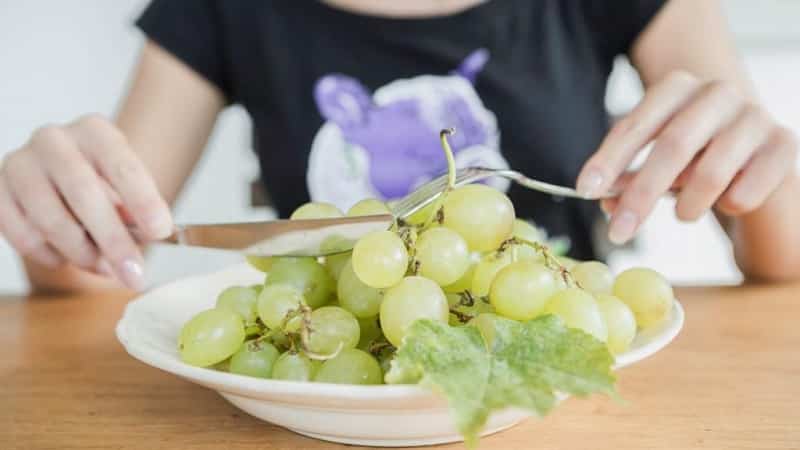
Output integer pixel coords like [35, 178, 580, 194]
[386, 316, 616, 446]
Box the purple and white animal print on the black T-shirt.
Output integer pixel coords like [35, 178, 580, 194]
[307, 49, 508, 210]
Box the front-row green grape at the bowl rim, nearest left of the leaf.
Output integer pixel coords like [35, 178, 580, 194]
[314, 348, 383, 384]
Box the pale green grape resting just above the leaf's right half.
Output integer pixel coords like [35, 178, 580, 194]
[545, 288, 608, 342]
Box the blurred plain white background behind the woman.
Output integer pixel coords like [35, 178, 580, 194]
[0, 0, 800, 292]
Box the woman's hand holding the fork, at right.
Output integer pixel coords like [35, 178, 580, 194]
[577, 72, 798, 243]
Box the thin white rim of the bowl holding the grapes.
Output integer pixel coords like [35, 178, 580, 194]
[115, 265, 685, 401]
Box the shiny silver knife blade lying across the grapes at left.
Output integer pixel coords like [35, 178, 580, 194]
[148, 214, 394, 256]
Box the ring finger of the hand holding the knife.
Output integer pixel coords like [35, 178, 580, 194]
[4, 140, 97, 269]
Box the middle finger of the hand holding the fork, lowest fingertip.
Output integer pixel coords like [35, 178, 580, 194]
[609, 83, 742, 244]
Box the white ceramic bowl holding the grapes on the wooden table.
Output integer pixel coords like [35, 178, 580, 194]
[116, 264, 683, 447]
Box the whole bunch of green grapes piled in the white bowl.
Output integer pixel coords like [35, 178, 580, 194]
[179, 131, 674, 384]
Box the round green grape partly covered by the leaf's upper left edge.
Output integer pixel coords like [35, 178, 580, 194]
[380, 276, 450, 347]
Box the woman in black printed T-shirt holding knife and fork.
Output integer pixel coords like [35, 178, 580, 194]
[0, 0, 800, 291]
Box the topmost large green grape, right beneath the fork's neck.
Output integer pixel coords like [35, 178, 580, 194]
[443, 184, 514, 252]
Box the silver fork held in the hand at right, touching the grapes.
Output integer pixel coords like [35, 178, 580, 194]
[391, 167, 618, 219]
